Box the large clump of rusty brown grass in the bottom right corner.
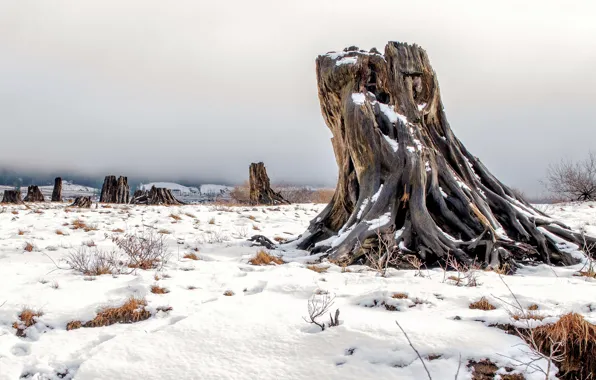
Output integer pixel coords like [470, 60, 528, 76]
[533, 313, 596, 379]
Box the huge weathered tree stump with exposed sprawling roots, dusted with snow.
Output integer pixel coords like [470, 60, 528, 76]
[295, 42, 596, 266]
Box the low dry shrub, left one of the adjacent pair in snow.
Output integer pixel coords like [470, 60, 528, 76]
[66, 245, 120, 276]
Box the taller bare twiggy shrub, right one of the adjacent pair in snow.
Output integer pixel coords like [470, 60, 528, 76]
[112, 229, 170, 270]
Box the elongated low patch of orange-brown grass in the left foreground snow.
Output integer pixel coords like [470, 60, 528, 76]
[66, 297, 151, 330]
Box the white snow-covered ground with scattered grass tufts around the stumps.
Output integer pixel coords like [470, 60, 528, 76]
[0, 200, 596, 380]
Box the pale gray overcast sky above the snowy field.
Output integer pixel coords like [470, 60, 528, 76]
[0, 0, 596, 193]
